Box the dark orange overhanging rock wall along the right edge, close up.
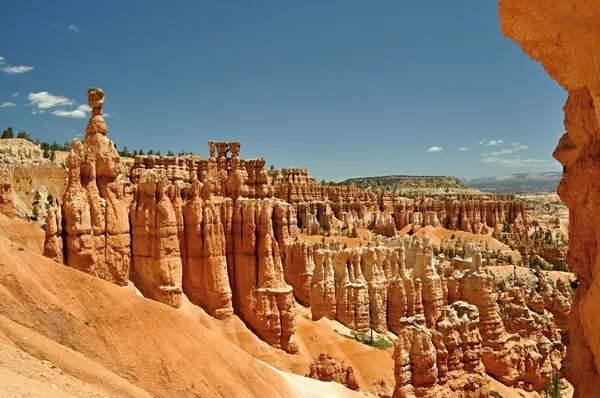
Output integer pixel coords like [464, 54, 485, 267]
[500, 0, 600, 397]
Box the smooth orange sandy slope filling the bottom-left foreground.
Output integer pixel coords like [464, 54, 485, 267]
[0, 233, 364, 397]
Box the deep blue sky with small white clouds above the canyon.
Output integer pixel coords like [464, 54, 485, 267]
[0, 0, 566, 180]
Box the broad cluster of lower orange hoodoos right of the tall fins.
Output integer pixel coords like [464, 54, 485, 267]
[284, 238, 569, 396]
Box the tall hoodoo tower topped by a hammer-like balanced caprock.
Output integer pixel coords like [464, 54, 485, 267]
[62, 89, 132, 286]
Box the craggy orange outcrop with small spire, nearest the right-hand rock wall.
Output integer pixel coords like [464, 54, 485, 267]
[449, 253, 565, 390]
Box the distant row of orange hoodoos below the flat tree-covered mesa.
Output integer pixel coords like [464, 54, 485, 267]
[273, 169, 529, 236]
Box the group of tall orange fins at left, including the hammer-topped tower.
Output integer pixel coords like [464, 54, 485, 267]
[45, 88, 298, 352]
